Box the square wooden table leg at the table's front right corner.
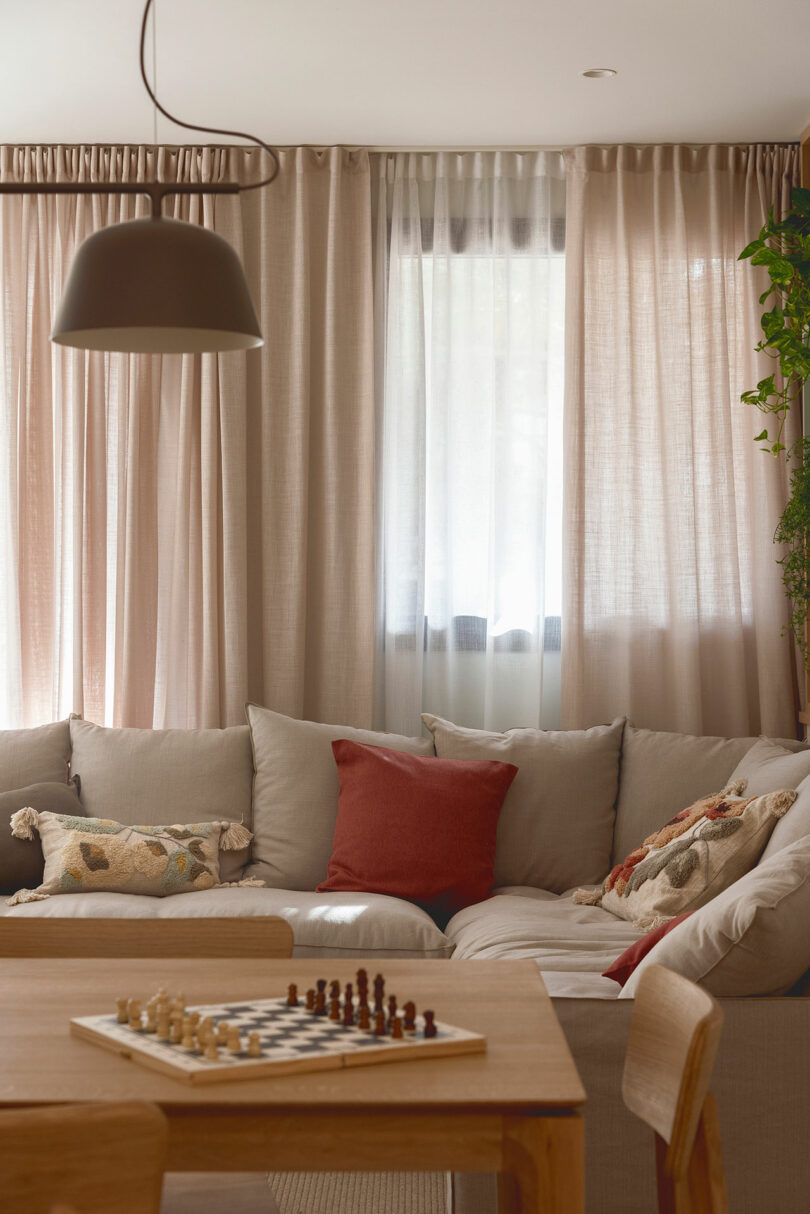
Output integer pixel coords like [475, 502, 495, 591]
[498, 1114, 585, 1214]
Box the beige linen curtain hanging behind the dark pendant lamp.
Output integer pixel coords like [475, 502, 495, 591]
[0, 147, 374, 727]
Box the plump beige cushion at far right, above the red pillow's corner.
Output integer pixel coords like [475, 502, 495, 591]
[621, 835, 810, 999]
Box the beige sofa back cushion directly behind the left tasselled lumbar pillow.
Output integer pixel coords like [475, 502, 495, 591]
[70, 716, 253, 881]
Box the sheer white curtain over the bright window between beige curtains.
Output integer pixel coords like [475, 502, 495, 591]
[373, 152, 565, 732]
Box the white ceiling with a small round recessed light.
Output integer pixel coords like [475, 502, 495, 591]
[0, 0, 810, 147]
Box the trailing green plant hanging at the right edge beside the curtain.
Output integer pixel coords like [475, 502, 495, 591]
[740, 188, 810, 665]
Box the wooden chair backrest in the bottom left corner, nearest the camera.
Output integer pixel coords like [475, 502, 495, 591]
[0, 1101, 169, 1214]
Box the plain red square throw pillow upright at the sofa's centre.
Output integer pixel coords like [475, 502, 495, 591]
[318, 741, 517, 915]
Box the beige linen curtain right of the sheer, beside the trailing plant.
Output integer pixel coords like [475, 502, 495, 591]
[562, 146, 799, 736]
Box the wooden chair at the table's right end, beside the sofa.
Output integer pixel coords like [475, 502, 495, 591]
[622, 965, 727, 1214]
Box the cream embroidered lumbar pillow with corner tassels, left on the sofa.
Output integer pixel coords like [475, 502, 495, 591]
[7, 806, 265, 906]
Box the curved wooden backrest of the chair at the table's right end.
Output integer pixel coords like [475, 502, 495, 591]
[622, 965, 723, 1181]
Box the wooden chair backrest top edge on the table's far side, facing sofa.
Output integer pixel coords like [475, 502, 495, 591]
[0, 917, 293, 960]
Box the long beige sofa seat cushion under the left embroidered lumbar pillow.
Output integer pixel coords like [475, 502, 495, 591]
[0, 889, 453, 958]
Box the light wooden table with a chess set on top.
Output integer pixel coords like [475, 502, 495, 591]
[0, 956, 585, 1214]
